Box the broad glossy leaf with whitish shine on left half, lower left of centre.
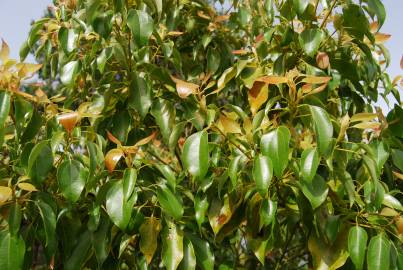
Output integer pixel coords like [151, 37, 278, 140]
[106, 181, 135, 230]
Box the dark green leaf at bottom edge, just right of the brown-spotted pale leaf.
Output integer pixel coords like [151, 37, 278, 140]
[186, 234, 215, 270]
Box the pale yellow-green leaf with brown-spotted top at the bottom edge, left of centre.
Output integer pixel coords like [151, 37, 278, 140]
[162, 223, 183, 270]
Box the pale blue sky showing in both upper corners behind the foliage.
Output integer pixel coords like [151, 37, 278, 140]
[0, 0, 403, 107]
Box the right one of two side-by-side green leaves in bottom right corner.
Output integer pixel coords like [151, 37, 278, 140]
[367, 233, 390, 270]
